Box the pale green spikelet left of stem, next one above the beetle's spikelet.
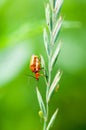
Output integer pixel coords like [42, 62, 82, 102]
[43, 28, 50, 56]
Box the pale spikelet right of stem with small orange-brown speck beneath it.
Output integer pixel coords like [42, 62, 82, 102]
[47, 71, 62, 102]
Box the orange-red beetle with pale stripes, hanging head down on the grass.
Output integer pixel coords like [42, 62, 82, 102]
[30, 55, 44, 80]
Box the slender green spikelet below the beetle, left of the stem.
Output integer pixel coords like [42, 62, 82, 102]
[36, 88, 46, 116]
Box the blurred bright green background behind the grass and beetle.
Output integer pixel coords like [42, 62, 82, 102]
[0, 0, 86, 130]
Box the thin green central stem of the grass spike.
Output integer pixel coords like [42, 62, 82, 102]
[43, 1, 60, 130]
